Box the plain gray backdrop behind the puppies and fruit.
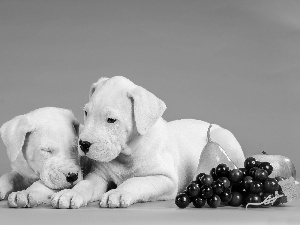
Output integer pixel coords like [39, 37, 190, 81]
[0, 0, 300, 174]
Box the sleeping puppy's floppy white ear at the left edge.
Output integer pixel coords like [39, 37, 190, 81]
[0, 115, 34, 162]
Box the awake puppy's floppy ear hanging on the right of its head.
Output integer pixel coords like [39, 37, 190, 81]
[128, 86, 167, 135]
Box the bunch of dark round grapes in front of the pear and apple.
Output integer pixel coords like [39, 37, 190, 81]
[175, 157, 286, 208]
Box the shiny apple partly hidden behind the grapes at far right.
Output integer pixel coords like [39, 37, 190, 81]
[252, 152, 296, 180]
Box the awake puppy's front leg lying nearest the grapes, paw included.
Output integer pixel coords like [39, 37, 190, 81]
[100, 175, 177, 208]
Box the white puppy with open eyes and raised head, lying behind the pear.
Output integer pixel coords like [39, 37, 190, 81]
[52, 77, 245, 208]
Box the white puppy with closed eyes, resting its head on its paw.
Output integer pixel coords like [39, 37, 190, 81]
[0, 107, 82, 207]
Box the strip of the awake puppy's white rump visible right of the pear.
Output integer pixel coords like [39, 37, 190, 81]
[210, 126, 245, 168]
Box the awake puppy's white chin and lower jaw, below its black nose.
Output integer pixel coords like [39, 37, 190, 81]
[86, 144, 121, 162]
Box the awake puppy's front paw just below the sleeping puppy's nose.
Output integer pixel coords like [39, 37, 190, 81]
[51, 189, 87, 209]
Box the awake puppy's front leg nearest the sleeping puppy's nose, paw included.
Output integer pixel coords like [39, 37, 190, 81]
[51, 173, 108, 209]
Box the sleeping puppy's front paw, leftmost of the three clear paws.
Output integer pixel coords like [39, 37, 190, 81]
[8, 190, 43, 208]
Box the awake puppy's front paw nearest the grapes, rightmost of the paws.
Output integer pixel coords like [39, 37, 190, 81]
[100, 189, 134, 208]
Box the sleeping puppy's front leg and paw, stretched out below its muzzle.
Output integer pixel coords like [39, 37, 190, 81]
[8, 181, 55, 208]
